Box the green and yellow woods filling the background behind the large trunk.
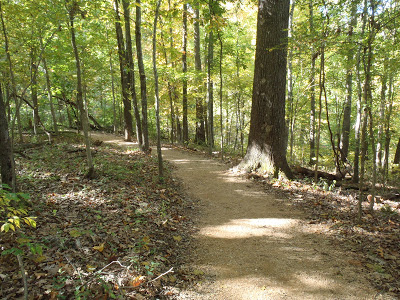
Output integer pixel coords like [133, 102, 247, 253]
[1, 0, 399, 183]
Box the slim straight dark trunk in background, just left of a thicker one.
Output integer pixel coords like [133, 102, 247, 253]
[182, 3, 189, 144]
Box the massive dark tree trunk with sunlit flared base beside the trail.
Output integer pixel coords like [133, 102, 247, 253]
[239, 0, 293, 178]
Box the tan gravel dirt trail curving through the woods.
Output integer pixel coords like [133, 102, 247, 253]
[93, 135, 383, 300]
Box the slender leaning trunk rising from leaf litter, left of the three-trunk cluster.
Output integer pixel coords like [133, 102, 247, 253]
[69, 3, 95, 179]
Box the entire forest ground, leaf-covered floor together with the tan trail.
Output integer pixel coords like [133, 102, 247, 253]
[0, 133, 400, 299]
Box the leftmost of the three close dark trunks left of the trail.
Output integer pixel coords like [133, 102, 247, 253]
[115, 0, 133, 141]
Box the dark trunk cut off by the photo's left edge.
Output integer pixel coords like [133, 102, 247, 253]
[0, 85, 16, 191]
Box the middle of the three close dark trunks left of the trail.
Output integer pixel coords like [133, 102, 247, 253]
[122, 0, 143, 149]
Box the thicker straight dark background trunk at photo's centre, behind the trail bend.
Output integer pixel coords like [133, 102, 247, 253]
[194, 1, 206, 144]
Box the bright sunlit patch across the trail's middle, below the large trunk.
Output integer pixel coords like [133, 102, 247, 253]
[199, 218, 299, 239]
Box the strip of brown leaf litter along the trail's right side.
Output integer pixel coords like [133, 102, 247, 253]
[247, 173, 400, 298]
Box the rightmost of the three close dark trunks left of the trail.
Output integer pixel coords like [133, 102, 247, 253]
[135, 0, 150, 152]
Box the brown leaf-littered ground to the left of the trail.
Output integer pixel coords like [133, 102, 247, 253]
[0, 135, 198, 299]
